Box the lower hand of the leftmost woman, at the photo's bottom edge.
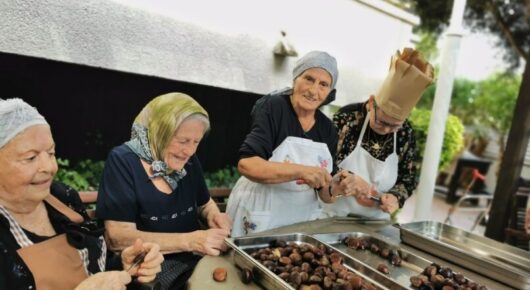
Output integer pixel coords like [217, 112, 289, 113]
[75, 271, 131, 290]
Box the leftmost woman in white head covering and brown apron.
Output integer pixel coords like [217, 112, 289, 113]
[0, 99, 163, 290]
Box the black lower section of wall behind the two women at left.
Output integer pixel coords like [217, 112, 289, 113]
[0, 53, 260, 171]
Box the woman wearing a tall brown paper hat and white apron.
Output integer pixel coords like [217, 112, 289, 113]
[324, 48, 434, 219]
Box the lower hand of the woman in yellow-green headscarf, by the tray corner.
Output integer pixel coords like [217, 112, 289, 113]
[190, 229, 230, 256]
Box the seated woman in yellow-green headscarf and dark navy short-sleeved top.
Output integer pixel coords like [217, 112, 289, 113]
[96, 93, 231, 289]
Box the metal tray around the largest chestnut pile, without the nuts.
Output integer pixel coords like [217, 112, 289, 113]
[225, 233, 408, 290]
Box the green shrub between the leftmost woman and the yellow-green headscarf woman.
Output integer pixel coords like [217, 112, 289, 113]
[55, 158, 105, 191]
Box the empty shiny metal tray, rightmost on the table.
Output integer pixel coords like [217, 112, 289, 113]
[395, 221, 530, 289]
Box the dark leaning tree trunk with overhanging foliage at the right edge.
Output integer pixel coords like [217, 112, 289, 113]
[403, 0, 530, 240]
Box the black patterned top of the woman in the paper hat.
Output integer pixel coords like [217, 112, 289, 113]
[333, 102, 418, 207]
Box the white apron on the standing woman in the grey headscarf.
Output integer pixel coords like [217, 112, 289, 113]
[226, 137, 333, 237]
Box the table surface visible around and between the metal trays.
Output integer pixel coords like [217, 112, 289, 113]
[188, 218, 512, 290]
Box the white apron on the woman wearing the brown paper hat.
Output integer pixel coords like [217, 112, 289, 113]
[322, 115, 399, 219]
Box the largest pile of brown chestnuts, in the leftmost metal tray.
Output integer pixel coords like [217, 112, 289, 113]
[249, 240, 377, 290]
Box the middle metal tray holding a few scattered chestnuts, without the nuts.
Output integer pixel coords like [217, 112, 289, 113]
[312, 232, 431, 289]
